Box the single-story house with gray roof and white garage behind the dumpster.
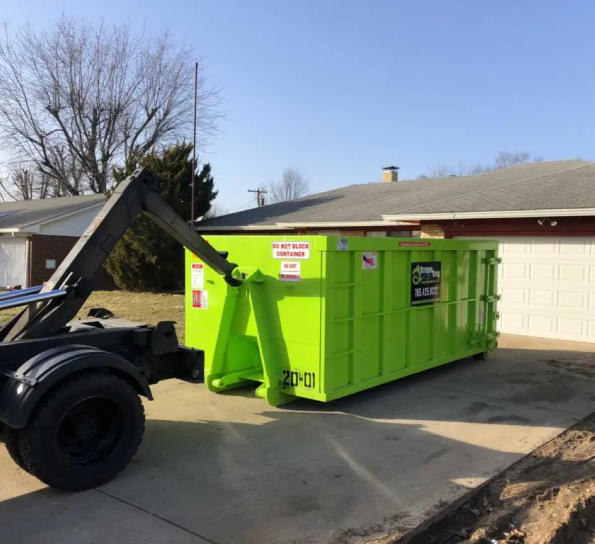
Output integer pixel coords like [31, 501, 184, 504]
[199, 160, 595, 343]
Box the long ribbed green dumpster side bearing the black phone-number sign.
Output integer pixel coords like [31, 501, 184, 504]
[323, 239, 497, 400]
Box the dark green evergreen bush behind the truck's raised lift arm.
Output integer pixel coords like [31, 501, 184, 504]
[106, 143, 217, 291]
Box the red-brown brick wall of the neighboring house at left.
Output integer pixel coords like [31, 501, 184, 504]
[28, 234, 116, 290]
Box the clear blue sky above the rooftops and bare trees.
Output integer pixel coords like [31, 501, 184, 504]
[0, 0, 595, 211]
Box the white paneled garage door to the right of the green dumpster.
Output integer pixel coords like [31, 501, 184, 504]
[456, 236, 595, 343]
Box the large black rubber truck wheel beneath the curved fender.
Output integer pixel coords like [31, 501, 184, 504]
[19, 372, 145, 491]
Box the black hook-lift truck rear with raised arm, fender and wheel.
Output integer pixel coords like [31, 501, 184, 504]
[0, 169, 243, 491]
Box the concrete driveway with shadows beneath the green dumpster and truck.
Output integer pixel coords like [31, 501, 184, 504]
[0, 336, 595, 544]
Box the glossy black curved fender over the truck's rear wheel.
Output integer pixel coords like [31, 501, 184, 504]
[0, 345, 153, 429]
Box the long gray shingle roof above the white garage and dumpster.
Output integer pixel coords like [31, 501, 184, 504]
[199, 159, 595, 228]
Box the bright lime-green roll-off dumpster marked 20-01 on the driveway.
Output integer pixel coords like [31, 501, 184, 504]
[185, 235, 499, 406]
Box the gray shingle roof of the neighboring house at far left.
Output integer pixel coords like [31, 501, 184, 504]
[0, 195, 105, 229]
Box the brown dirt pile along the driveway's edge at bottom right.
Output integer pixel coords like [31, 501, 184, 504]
[402, 414, 595, 544]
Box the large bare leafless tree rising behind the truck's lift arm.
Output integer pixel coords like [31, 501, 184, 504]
[0, 16, 220, 195]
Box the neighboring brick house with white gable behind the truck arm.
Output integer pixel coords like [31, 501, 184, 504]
[0, 195, 114, 289]
